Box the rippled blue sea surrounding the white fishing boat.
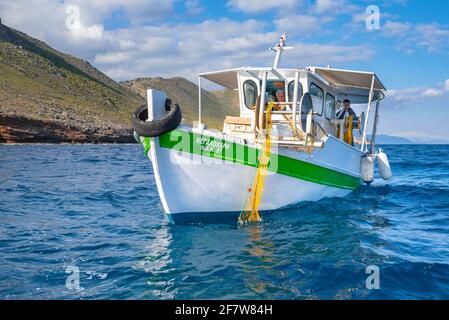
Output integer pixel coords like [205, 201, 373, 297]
[0, 145, 449, 299]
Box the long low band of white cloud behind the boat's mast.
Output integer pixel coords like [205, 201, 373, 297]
[87, 19, 373, 80]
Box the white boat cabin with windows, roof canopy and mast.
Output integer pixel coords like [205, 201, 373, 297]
[198, 37, 386, 151]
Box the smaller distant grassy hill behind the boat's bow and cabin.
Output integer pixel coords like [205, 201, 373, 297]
[122, 77, 239, 130]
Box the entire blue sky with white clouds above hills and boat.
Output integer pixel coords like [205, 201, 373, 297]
[0, 0, 449, 141]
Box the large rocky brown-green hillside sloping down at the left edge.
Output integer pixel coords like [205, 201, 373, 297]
[0, 20, 144, 142]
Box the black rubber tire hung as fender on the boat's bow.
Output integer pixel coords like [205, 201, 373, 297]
[131, 99, 182, 137]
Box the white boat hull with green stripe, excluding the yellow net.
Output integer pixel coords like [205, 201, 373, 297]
[141, 127, 362, 221]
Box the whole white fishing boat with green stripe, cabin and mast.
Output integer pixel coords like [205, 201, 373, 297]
[132, 34, 391, 223]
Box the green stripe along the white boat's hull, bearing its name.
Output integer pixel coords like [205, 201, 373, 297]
[159, 130, 362, 189]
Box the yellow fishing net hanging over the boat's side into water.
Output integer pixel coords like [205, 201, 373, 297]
[239, 102, 274, 224]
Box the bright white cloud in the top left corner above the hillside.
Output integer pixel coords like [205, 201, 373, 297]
[0, 0, 177, 59]
